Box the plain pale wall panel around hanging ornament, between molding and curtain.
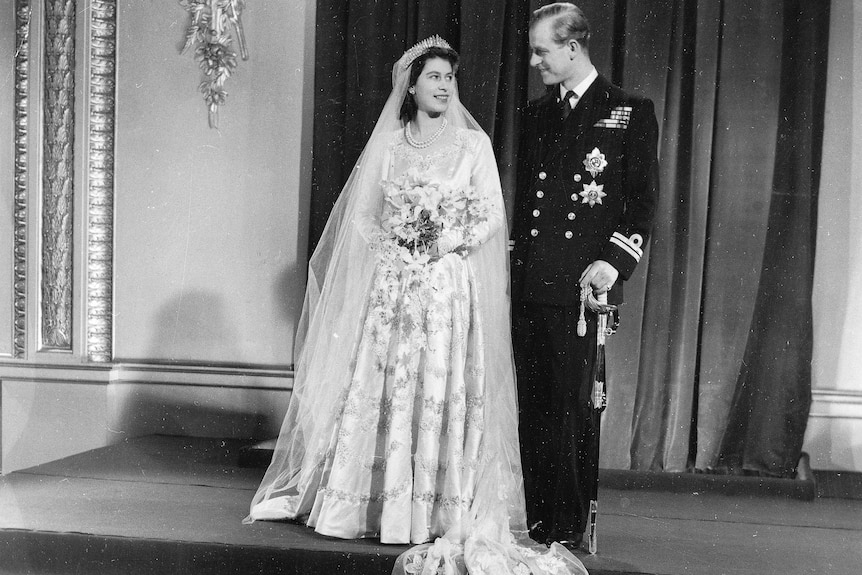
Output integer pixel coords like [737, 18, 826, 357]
[114, 1, 314, 366]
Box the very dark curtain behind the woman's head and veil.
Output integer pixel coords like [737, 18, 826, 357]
[309, 0, 531, 253]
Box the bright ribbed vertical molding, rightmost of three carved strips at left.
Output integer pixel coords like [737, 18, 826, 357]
[87, 0, 117, 362]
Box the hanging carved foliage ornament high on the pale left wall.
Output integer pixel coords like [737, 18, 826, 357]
[179, 0, 248, 128]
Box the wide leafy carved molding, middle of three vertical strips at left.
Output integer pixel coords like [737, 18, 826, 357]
[40, 0, 76, 351]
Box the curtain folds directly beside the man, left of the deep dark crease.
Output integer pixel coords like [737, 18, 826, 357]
[614, 2, 721, 471]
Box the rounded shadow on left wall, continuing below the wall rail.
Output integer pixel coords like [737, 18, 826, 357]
[103, 289, 290, 443]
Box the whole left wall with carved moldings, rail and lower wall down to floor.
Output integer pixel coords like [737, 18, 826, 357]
[0, 0, 314, 474]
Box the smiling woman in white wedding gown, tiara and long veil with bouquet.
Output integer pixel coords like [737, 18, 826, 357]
[246, 36, 586, 575]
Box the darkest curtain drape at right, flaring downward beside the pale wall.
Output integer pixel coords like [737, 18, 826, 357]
[718, 0, 829, 477]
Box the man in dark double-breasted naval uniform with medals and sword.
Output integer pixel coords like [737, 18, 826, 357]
[511, 2, 658, 549]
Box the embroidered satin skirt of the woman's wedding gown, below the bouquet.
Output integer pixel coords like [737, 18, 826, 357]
[304, 254, 485, 543]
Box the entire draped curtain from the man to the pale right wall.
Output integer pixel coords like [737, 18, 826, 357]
[616, 0, 829, 476]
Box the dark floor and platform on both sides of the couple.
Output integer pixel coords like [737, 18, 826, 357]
[0, 436, 862, 575]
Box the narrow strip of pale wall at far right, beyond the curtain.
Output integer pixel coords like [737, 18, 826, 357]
[803, 0, 862, 471]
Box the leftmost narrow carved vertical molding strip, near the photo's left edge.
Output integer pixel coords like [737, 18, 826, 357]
[12, 0, 33, 358]
